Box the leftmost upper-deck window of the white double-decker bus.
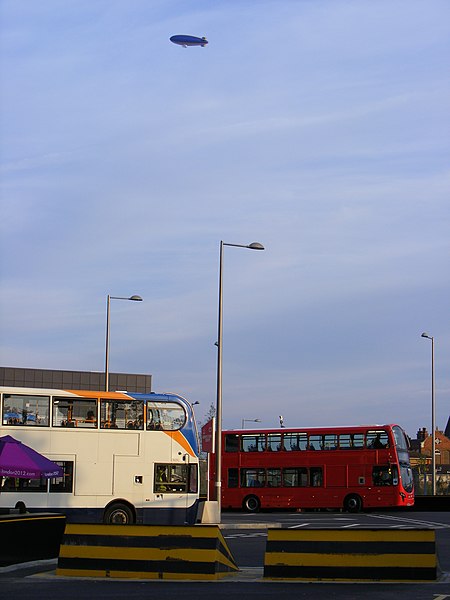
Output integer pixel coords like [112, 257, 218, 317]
[2, 394, 50, 427]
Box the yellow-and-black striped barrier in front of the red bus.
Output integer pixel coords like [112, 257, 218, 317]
[264, 529, 437, 581]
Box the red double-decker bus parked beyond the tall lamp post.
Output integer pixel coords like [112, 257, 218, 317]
[210, 425, 414, 512]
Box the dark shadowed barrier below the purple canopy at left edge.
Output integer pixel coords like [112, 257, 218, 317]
[0, 512, 66, 567]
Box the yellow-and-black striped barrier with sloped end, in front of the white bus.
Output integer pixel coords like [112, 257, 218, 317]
[56, 524, 239, 580]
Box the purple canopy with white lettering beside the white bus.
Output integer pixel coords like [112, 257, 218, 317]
[0, 435, 63, 479]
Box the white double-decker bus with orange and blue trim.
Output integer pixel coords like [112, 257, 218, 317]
[0, 386, 199, 524]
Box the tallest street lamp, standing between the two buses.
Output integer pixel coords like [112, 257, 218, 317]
[214, 241, 264, 523]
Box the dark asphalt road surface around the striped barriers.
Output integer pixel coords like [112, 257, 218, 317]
[0, 512, 450, 600]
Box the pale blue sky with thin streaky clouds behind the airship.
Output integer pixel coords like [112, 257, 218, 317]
[0, 0, 450, 437]
